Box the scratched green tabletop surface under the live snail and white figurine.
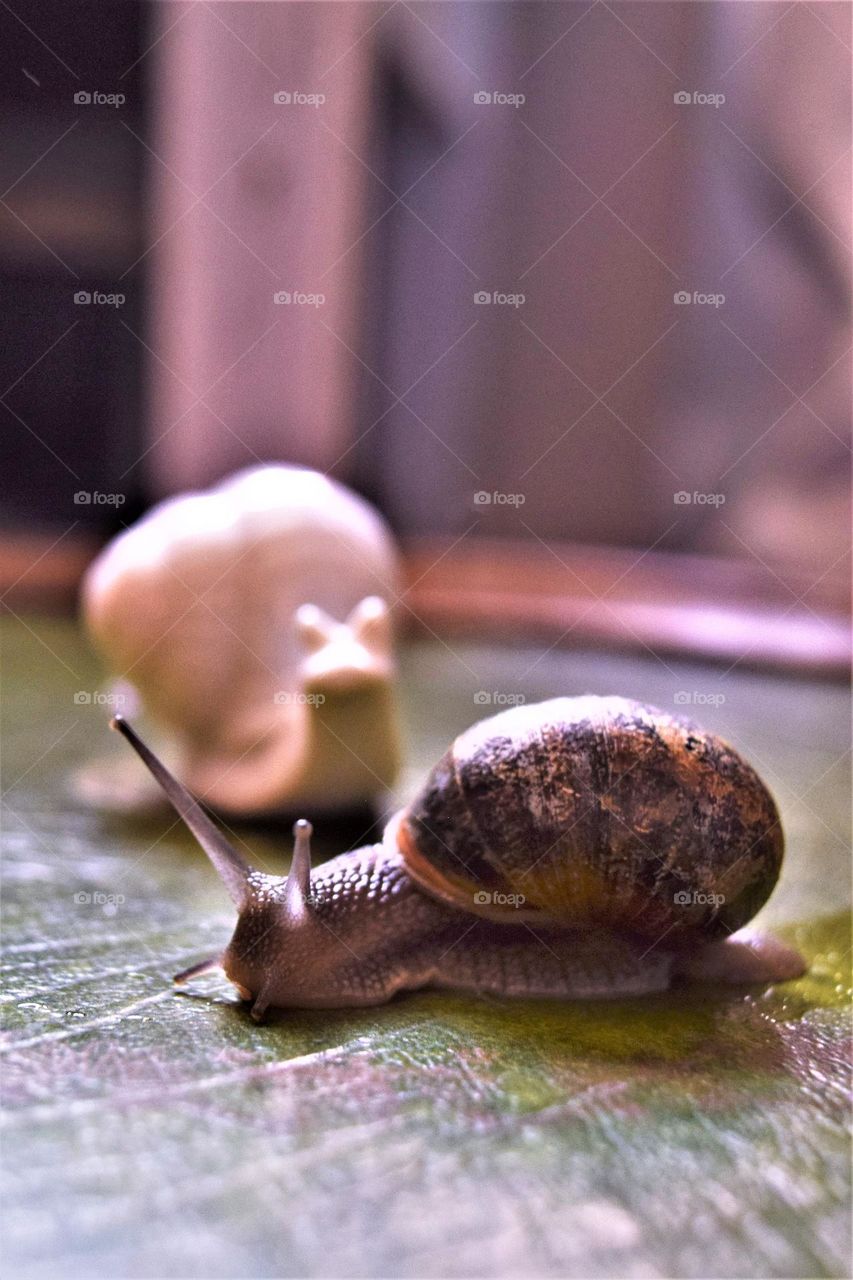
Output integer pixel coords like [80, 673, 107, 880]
[3, 617, 850, 1277]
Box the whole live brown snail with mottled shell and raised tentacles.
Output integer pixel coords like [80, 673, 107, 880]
[113, 695, 804, 1020]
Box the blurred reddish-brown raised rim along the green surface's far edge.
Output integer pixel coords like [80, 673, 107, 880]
[0, 535, 852, 680]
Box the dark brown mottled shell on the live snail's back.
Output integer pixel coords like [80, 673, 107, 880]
[394, 695, 784, 946]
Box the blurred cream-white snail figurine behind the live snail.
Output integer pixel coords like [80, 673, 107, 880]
[82, 466, 400, 814]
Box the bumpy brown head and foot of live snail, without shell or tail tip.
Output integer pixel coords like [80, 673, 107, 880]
[222, 845, 674, 1009]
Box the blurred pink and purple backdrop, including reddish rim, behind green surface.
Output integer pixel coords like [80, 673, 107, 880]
[0, 0, 850, 671]
